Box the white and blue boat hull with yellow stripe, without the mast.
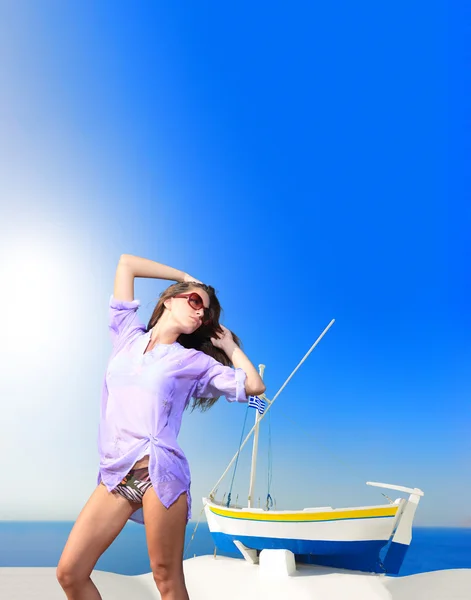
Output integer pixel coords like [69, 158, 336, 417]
[204, 499, 401, 573]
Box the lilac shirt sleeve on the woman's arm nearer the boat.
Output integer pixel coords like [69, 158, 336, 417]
[194, 355, 248, 402]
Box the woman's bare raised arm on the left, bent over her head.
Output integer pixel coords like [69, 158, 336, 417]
[113, 254, 201, 302]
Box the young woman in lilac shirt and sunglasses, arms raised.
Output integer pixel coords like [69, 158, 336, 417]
[57, 254, 265, 600]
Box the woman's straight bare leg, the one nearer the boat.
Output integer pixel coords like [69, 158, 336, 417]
[142, 488, 189, 600]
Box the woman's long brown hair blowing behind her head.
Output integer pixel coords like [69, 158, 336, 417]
[147, 281, 241, 411]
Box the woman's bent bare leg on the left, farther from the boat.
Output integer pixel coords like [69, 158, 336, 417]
[56, 484, 140, 600]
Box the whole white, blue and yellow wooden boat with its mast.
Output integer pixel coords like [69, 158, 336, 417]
[203, 320, 424, 574]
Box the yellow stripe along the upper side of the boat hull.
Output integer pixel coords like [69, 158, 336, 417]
[209, 506, 399, 522]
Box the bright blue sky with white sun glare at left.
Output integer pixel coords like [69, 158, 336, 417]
[0, 2, 471, 525]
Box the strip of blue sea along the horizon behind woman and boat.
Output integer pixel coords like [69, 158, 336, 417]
[0, 521, 471, 576]
